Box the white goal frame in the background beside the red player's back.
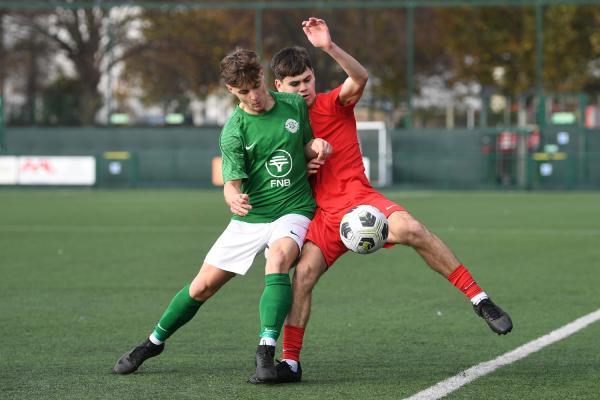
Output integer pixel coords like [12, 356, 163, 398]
[356, 121, 392, 187]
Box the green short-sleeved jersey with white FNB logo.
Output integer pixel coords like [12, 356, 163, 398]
[219, 92, 315, 223]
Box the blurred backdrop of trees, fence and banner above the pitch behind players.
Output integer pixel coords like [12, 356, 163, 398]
[0, 0, 600, 190]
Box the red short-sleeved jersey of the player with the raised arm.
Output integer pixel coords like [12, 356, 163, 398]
[309, 85, 376, 213]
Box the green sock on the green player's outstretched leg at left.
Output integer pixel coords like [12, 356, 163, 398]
[152, 285, 204, 342]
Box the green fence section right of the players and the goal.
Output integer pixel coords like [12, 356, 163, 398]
[392, 126, 600, 189]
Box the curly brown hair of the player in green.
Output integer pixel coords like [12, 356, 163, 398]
[221, 48, 262, 88]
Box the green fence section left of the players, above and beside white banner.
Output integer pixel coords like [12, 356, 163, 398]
[6, 128, 220, 187]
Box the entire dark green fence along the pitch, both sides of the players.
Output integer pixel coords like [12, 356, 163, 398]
[4, 126, 600, 189]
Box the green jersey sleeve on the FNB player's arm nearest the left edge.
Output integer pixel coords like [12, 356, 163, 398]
[219, 124, 248, 182]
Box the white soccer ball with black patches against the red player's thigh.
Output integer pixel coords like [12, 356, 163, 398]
[340, 205, 388, 254]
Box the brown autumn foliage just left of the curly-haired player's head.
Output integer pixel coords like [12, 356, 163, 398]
[122, 9, 254, 111]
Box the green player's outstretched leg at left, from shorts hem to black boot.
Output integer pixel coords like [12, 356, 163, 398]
[113, 263, 235, 374]
